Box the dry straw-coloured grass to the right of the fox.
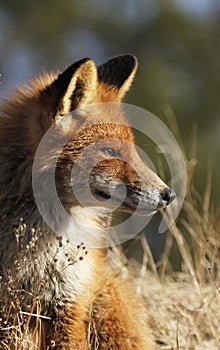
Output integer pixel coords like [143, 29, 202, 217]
[139, 111, 220, 350]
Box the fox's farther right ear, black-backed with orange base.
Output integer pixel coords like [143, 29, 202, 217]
[98, 55, 138, 101]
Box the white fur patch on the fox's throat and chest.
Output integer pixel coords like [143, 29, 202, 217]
[26, 208, 107, 305]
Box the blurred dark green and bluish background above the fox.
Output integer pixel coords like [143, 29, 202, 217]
[0, 0, 220, 262]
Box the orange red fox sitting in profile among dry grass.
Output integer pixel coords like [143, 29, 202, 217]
[0, 54, 175, 350]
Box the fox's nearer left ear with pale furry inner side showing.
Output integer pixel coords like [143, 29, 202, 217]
[44, 58, 97, 114]
